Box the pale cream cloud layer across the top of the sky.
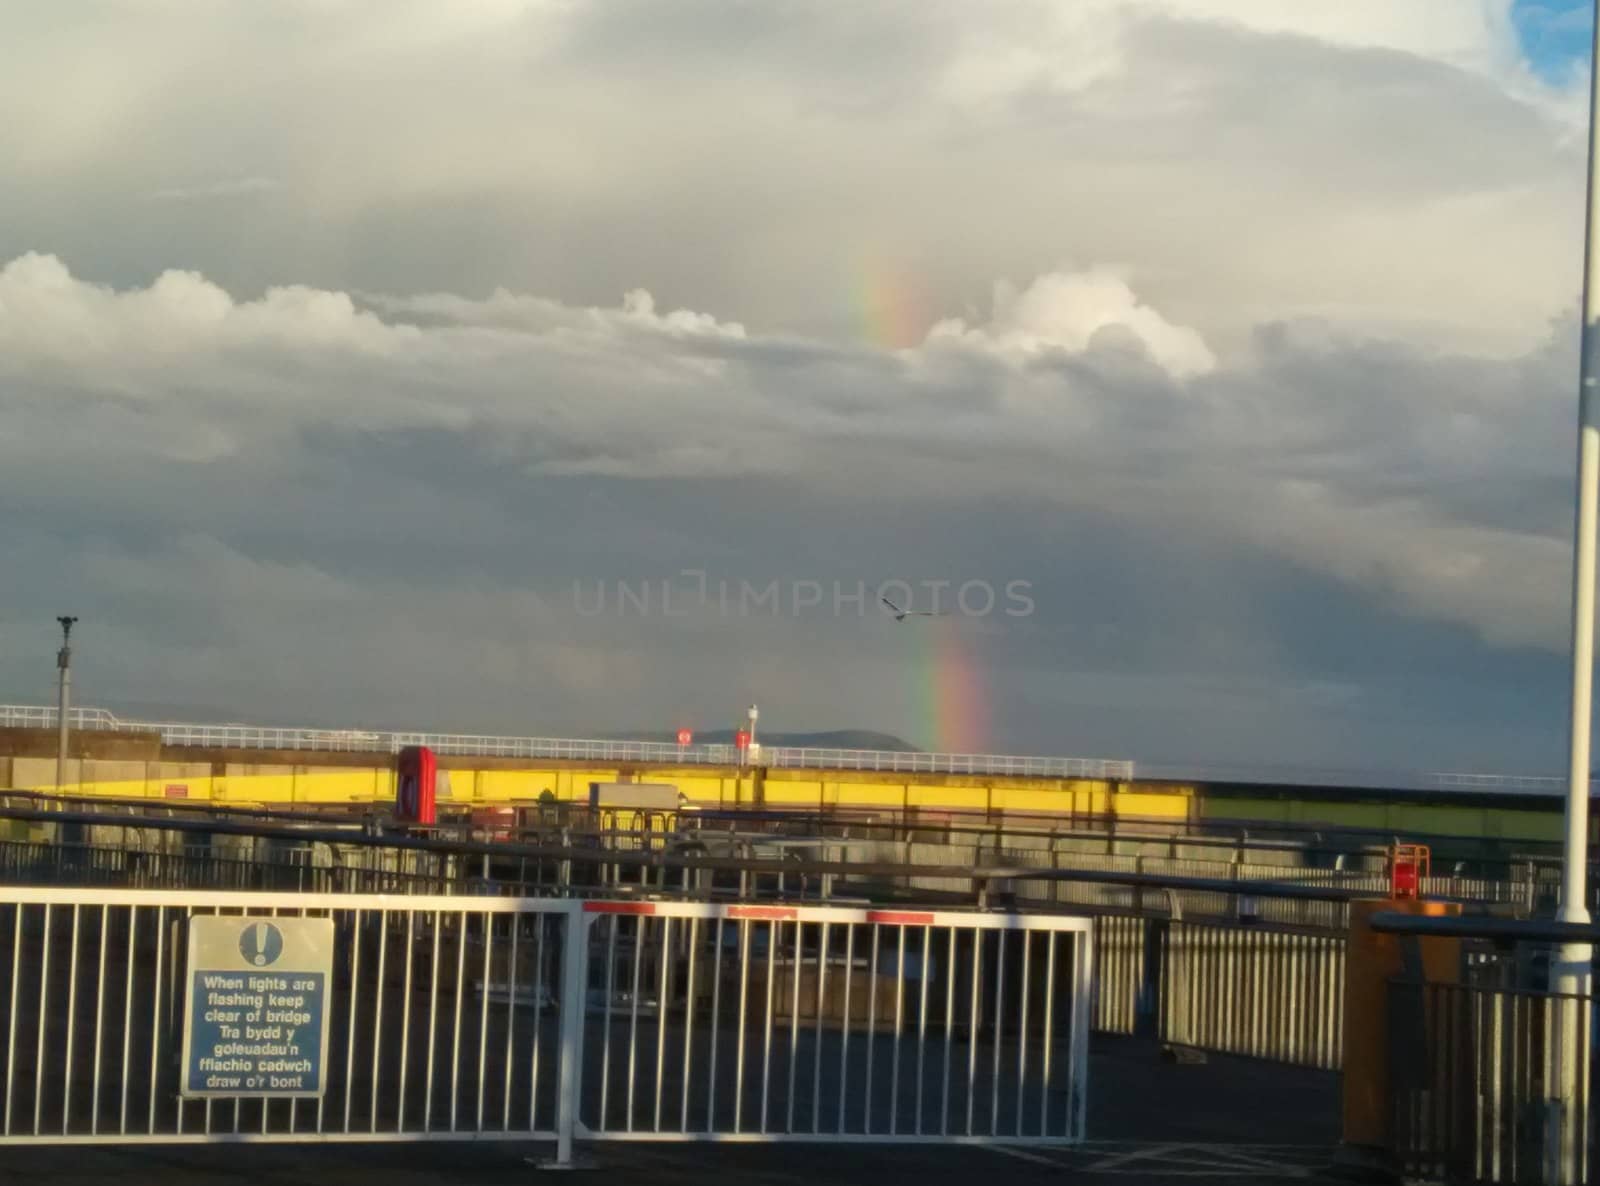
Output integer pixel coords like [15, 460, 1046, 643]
[0, 0, 1582, 355]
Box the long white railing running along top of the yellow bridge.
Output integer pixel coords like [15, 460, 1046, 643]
[0, 704, 1133, 779]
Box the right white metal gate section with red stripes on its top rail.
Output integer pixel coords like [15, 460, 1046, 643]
[578, 903, 1091, 1143]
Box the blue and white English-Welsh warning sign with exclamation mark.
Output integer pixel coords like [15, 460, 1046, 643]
[182, 917, 333, 1098]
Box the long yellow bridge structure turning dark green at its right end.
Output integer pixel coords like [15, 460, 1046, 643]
[0, 706, 1562, 843]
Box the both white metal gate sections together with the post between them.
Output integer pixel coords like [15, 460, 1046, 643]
[0, 888, 1093, 1160]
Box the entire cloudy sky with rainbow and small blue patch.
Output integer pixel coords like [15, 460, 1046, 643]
[0, 0, 1587, 771]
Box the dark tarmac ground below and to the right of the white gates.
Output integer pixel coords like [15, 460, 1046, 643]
[0, 1037, 1339, 1186]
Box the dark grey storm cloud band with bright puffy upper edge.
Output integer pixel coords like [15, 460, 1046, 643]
[0, 249, 1566, 760]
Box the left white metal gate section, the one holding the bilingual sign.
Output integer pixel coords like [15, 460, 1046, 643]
[0, 888, 570, 1144]
